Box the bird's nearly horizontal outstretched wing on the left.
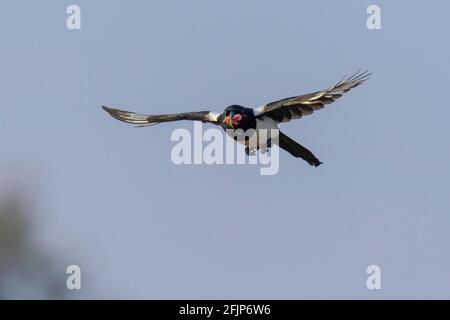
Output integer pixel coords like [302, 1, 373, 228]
[102, 106, 219, 127]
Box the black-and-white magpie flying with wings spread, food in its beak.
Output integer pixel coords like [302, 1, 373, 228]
[102, 71, 371, 167]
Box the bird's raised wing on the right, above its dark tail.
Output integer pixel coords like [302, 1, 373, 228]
[254, 71, 371, 123]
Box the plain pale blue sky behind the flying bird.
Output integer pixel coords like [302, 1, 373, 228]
[0, 0, 450, 299]
